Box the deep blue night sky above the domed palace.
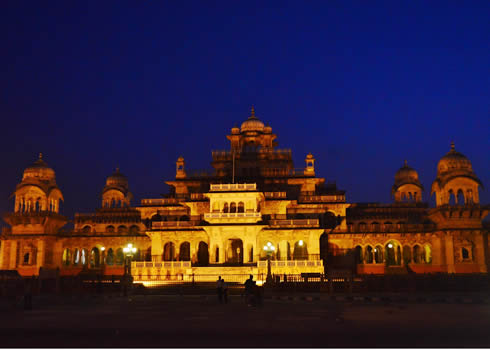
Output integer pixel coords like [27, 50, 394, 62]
[0, 0, 490, 221]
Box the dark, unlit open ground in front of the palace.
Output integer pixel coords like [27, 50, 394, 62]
[0, 295, 490, 348]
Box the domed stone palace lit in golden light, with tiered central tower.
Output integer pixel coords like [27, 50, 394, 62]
[0, 109, 490, 280]
